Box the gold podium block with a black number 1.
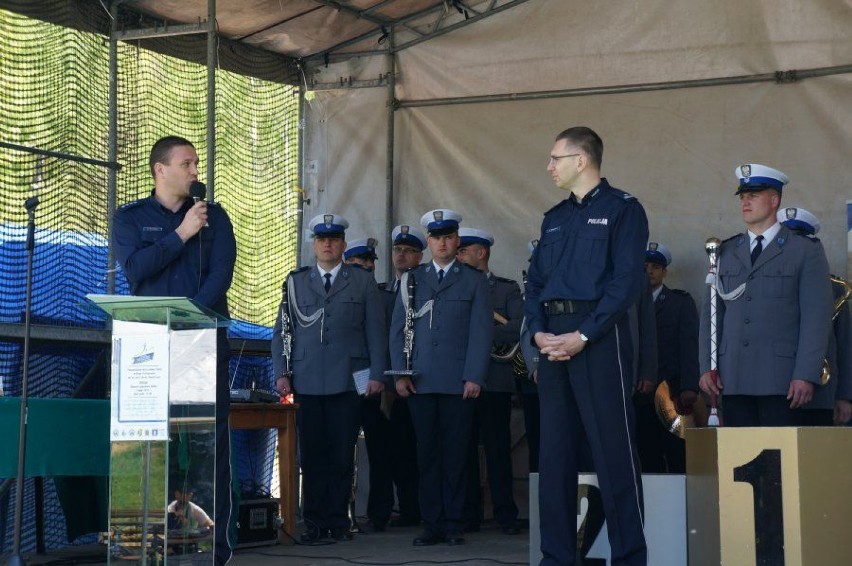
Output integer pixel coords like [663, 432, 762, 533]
[686, 427, 852, 566]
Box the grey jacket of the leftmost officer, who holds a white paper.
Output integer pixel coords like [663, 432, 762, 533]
[272, 264, 387, 395]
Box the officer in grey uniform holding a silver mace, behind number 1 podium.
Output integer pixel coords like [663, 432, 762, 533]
[699, 163, 832, 426]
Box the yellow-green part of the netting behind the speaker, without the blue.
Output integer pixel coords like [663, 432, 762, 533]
[0, 7, 299, 325]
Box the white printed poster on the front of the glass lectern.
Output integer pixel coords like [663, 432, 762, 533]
[110, 323, 169, 442]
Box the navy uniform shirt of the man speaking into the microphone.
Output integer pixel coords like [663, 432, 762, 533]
[113, 193, 237, 316]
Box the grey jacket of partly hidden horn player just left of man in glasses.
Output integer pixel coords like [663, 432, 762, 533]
[485, 273, 524, 393]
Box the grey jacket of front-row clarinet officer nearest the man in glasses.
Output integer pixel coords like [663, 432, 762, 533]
[390, 261, 494, 395]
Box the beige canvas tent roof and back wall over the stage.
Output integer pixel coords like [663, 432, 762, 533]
[4, 0, 852, 300]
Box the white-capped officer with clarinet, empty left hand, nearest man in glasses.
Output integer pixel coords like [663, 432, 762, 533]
[390, 209, 494, 546]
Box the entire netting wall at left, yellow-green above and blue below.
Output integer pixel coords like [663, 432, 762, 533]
[0, 0, 299, 554]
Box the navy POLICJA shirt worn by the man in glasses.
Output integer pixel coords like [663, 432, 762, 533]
[524, 179, 648, 341]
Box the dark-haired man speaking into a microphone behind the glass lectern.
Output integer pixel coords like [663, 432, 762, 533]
[112, 136, 237, 564]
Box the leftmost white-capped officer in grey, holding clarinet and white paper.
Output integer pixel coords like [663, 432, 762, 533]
[272, 214, 387, 543]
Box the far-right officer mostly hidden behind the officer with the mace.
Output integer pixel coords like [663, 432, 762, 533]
[777, 207, 852, 426]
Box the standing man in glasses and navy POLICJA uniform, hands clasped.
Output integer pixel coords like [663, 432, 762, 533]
[524, 126, 648, 565]
